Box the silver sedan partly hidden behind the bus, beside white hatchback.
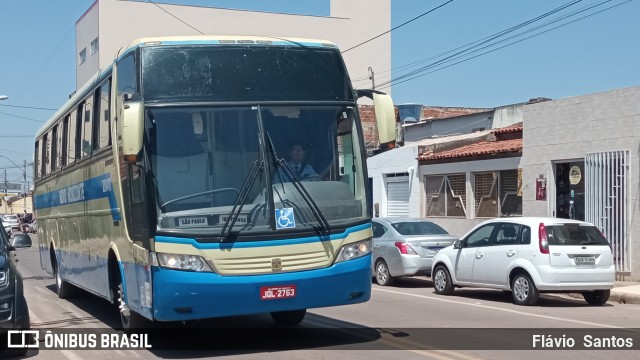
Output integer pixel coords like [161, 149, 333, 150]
[372, 218, 458, 286]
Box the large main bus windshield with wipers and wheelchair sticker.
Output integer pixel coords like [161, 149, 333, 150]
[145, 105, 367, 236]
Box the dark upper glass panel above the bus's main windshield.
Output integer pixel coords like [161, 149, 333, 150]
[142, 45, 354, 102]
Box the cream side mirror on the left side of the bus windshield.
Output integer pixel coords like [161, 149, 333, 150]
[122, 101, 144, 163]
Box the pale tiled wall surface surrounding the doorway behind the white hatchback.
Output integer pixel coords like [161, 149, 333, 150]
[522, 86, 640, 280]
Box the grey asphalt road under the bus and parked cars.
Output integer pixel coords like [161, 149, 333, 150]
[10, 236, 640, 360]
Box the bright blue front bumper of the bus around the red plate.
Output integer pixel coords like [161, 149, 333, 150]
[153, 255, 371, 321]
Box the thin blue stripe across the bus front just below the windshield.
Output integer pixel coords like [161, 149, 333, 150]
[155, 224, 371, 250]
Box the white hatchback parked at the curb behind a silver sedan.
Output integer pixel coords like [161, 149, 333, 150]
[432, 217, 615, 305]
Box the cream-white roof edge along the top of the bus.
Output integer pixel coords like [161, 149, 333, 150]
[35, 35, 337, 139]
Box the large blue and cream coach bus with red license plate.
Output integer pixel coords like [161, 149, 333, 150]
[34, 36, 395, 328]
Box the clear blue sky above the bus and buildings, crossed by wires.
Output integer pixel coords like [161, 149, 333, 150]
[0, 0, 640, 187]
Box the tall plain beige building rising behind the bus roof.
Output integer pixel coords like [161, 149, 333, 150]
[76, 0, 391, 88]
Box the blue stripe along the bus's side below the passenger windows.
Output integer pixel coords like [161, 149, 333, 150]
[33, 174, 122, 221]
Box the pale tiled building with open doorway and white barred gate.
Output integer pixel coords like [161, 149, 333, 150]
[521, 86, 640, 281]
